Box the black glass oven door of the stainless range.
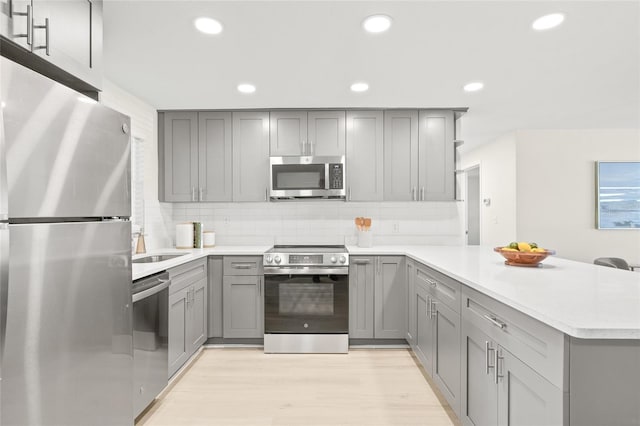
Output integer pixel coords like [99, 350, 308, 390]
[264, 275, 349, 334]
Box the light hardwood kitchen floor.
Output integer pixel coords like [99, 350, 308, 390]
[136, 348, 459, 426]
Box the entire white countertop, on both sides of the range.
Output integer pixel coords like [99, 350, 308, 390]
[133, 246, 640, 339]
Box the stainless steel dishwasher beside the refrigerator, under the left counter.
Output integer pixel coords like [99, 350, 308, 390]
[132, 272, 171, 418]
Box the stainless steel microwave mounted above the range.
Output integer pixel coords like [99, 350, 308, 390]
[269, 156, 346, 200]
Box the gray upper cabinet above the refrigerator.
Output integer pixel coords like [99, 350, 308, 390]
[0, 0, 102, 89]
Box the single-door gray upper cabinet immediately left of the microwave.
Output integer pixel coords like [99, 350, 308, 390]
[233, 111, 270, 201]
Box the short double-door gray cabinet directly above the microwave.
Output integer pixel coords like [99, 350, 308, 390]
[270, 110, 345, 156]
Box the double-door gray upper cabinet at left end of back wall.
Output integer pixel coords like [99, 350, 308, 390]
[158, 111, 233, 202]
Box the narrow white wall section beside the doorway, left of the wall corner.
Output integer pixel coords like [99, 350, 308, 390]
[460, 133, 517, 246]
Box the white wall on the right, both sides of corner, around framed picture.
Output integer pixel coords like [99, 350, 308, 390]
[461, 129, 640, 264]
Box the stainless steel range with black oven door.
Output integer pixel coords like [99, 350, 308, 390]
[263, 246, 349, 353]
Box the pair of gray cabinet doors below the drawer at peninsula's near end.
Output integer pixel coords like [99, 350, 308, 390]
[461, 321, 564, 426]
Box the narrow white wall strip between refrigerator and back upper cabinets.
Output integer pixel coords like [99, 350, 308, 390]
[100, 80, 171, 249]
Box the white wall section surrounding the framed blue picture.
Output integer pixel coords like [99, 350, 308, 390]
[517, 130, 640, 264]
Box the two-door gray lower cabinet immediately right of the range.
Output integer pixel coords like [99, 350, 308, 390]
[349, 256, 407, 339]
